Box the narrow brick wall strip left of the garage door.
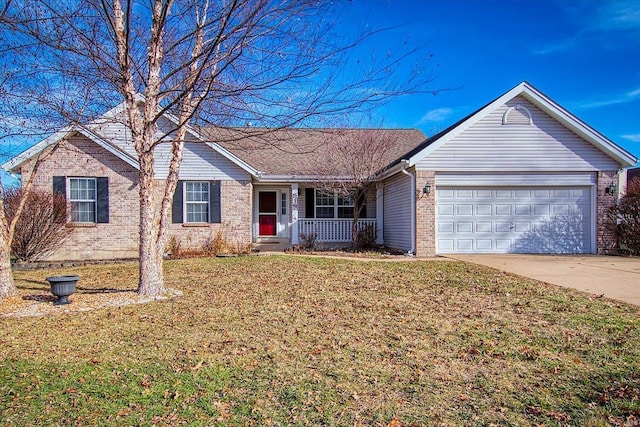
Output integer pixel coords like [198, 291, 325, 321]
[415, 170, 436, 257]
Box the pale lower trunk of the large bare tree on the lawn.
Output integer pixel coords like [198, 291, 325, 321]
[138, 152, 165, 296]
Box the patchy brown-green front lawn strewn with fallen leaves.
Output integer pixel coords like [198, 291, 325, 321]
[0, 257, 640, 426]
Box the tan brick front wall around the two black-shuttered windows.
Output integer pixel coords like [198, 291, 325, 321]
[21, 136, 252, 260]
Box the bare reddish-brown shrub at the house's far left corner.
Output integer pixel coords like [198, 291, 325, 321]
[4, 188, 70, 261]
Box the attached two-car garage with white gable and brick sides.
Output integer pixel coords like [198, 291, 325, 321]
[385, 82, 636, 256]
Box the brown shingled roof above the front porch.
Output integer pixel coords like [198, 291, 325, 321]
[199, 127, 426, 177]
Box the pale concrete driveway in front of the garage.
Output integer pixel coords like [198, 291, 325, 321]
[448, 254, 640, 306]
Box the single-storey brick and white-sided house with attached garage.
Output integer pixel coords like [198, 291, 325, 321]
[3, 82, 636, 259]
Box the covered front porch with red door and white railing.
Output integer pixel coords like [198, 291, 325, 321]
[253, 183, 383, 246]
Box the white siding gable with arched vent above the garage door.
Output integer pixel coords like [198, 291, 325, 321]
[417, 96, 619, 171]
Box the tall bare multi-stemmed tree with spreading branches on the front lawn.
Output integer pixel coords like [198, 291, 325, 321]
[0, 0, 436, 295]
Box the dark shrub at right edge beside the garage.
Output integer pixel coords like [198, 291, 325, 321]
[605, 178, 640, 255]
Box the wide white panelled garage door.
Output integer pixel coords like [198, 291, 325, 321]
[436, 186, 592, 254]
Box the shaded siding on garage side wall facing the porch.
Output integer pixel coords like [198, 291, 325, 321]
[383, 174, 413, 251]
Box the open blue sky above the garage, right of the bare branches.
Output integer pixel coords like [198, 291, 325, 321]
[348, 0, 640, 164]
